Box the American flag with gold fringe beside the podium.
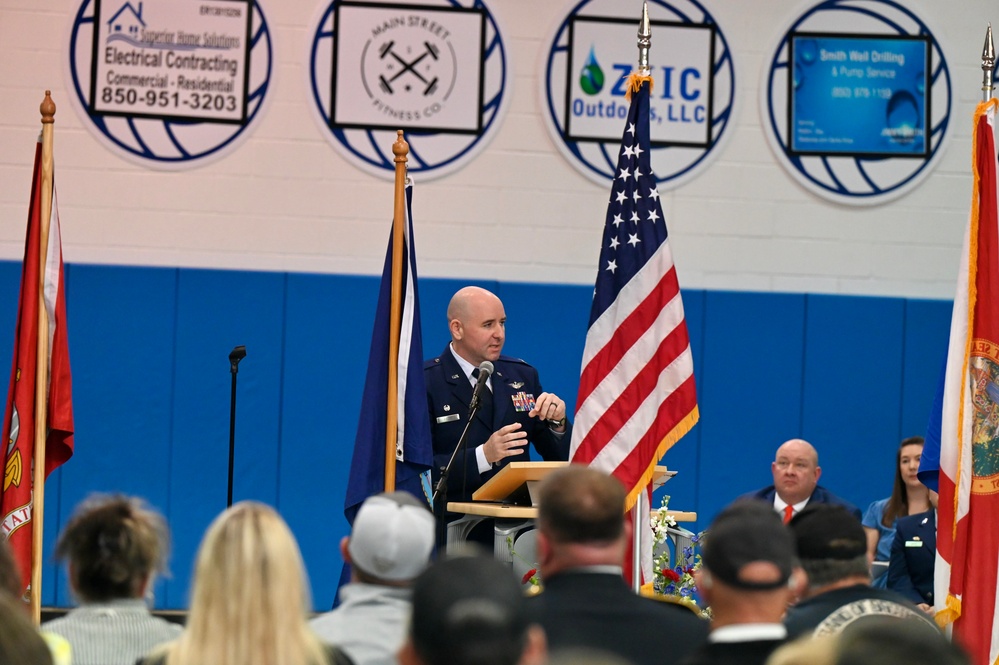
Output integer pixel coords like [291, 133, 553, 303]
[570, 75, 698, 508]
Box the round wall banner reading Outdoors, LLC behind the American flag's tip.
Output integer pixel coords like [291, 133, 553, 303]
[541, 0, 735, 189]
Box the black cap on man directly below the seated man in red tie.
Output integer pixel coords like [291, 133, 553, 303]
[701, 501, 795, 590]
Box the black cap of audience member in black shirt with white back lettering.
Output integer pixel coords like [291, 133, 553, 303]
[790, 503, 867, 561]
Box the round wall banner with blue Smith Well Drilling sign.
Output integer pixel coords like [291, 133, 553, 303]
[760, 0, 951, 205]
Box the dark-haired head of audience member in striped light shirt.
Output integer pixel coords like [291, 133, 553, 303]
[55, 495, 169, 602]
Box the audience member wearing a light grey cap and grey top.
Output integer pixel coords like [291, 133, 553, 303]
[309, 492, 434, 665]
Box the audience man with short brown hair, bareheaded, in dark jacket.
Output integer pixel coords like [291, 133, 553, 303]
[528, 465, 708, 665]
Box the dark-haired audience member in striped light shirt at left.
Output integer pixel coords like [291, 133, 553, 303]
[42, 496, 181, 665]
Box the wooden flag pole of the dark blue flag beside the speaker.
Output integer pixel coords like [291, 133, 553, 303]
[385, 129, 409, 492]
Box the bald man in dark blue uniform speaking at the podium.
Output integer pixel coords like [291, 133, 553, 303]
[424, 286, 572, 521]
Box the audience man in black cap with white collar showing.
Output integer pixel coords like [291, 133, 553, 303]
[681, 501, 804, 665]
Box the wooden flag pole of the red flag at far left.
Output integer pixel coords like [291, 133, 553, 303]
[30, 90, 55, 625]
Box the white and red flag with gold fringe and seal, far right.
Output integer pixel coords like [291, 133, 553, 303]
[919, 99, 999, 665]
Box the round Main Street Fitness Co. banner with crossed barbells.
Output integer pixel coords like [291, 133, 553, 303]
[308, 0, 509, 179]
